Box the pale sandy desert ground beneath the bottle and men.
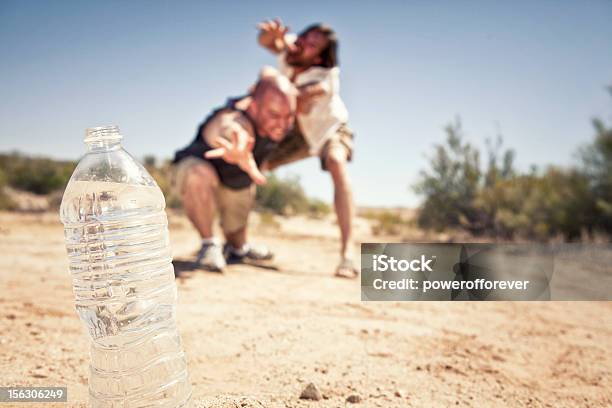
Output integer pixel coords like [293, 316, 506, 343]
[0, 212, 612, 408]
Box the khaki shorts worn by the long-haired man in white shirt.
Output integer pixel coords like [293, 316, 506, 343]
[265, 123, 354, 170]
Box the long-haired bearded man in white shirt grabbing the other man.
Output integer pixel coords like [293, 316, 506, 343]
[258, 20, 358, 278]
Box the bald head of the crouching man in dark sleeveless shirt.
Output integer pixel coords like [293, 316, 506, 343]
[248, 67, 297, 142]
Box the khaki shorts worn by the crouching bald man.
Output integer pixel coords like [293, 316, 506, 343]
[172, 157, 255, 234]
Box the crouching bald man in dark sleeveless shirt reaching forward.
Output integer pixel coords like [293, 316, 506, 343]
[173, 68, 297, 272]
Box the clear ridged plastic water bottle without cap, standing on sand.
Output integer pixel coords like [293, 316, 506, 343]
[60, 126, 191, 408]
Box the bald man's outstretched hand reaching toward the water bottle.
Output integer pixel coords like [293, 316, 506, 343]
[204, 130, 266, 184]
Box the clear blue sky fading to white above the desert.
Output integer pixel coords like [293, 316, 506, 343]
[0, 0, 612, 207]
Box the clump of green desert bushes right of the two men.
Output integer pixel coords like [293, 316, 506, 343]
[414, 108, 612, 240]
